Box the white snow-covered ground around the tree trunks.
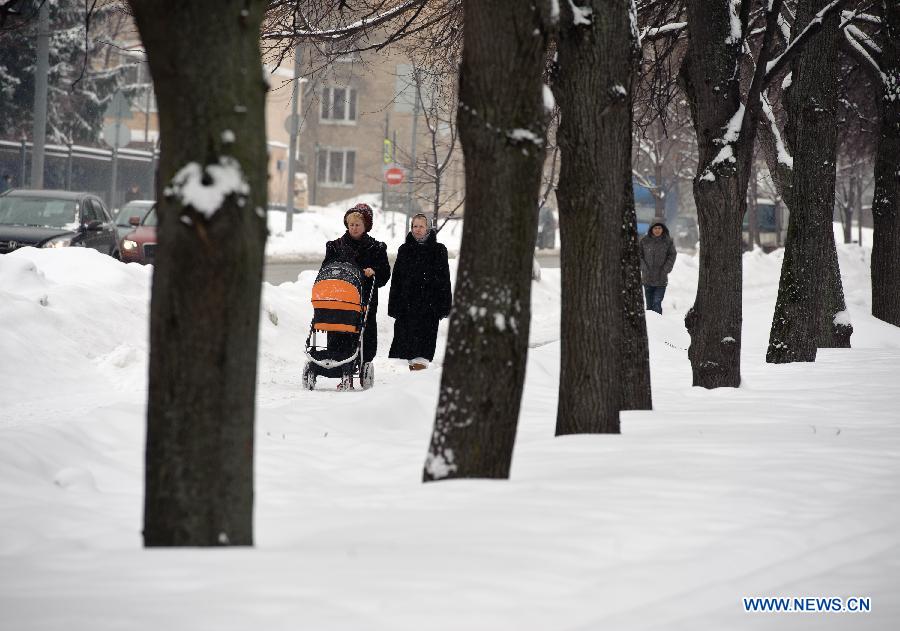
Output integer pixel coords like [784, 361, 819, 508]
[0, 208, 900, 631]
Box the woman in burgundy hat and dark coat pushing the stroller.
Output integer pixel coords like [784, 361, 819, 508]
[320, 204, 391, 388]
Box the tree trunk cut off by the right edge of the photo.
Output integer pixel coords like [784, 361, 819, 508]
[872, 0, 900, 326]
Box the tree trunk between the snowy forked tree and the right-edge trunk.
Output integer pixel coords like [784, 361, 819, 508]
[766, 0, 852, 363]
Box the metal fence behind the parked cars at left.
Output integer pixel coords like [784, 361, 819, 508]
[0, 140, 159, 208]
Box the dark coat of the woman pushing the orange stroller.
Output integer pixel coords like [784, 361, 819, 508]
[320, 232, 391, 362]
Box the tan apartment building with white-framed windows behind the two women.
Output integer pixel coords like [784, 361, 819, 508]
[298, 47, 464, 213]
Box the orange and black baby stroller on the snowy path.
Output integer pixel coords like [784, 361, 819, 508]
[303, 262, 375, 390]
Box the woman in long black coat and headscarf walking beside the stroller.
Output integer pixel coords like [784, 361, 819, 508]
[388, 214, 451, 370]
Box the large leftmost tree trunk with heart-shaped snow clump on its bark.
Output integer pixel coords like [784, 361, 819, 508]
[129, 0, 267, 546]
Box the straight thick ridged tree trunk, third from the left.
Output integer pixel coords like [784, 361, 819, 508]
[554, 0, 646, 435]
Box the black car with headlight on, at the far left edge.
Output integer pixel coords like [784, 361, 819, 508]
[0, 189, 119, 258]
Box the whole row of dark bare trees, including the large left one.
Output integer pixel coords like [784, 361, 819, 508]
[67, 0, 900, 546]
